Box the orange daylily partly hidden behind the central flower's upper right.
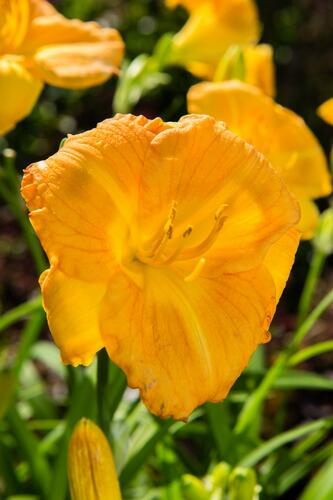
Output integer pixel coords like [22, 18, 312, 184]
[188, 81, 332, 239]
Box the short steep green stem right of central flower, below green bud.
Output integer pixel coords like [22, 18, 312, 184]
[297, 247, 327, 326]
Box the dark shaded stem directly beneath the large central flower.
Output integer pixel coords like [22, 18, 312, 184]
[97, 349, 110, 436]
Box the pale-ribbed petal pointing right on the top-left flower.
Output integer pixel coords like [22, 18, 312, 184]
[22, 2, 124, 88]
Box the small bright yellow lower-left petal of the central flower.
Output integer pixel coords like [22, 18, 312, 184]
[40, 265, 107, 366]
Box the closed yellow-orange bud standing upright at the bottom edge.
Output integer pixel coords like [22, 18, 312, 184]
[68, 418, 121, 500]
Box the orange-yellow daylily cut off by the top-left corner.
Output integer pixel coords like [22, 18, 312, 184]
[0, 0, 124, 134]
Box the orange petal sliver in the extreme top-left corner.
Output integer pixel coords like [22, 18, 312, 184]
[0, 0, 30, 54]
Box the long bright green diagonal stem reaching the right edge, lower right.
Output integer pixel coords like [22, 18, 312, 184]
[235, 290, 333, 434]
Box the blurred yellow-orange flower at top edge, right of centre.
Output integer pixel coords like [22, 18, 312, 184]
[170, 0, 260, 70]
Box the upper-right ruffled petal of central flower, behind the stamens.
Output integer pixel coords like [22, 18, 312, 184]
[139, 115, 299, 272]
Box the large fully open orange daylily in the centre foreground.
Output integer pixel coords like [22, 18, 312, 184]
[22, 115, 299, 419]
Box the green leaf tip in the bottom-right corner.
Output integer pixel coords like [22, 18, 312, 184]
[300, 457, 333, 500]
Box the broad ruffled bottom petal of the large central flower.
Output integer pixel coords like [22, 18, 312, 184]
[100, 266, 275, 419]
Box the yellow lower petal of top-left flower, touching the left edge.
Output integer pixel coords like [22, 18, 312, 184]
[0, 56, 43, 135]
